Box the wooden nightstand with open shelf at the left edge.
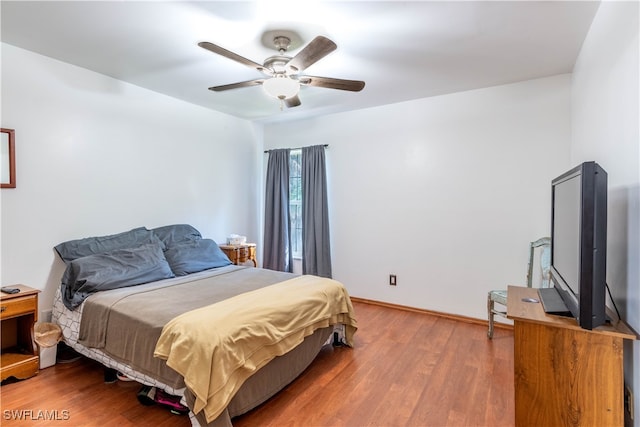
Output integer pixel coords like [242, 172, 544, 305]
[0, 285, 40, 381]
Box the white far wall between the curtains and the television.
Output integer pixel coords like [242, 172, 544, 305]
[264, 75, 571, 318]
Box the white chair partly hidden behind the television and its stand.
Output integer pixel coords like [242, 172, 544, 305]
[487, 237, 551, 339]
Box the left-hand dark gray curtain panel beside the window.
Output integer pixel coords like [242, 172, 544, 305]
[263, 149, 293, 272]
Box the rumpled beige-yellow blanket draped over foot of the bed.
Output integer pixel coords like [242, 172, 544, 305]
[154, 276, 357, 422]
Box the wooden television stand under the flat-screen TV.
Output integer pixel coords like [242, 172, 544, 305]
[507, 286, 637, 427]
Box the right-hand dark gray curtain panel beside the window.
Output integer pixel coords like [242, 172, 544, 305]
[302, 145, 331, 277]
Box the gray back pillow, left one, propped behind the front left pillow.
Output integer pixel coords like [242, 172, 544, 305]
[54, 227, 164, 264]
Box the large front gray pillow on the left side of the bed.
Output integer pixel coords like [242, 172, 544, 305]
[61, 243, 174, 310]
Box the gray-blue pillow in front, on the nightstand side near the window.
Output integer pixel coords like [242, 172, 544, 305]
[164, 239, 231, 276]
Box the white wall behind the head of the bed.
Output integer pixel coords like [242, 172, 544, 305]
[0, 44, 263, 309]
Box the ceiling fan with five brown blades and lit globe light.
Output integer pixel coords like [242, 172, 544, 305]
[198, 35, 364, 109]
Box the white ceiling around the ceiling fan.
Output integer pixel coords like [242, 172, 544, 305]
[0, 0, 599, 123]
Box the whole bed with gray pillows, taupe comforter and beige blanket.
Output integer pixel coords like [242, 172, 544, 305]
[52, 224, 357, 427]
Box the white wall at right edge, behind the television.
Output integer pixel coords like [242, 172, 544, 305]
[571, 1, 640, 426]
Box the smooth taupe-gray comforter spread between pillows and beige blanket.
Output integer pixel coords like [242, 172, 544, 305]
[78, 265, 294, 389]
